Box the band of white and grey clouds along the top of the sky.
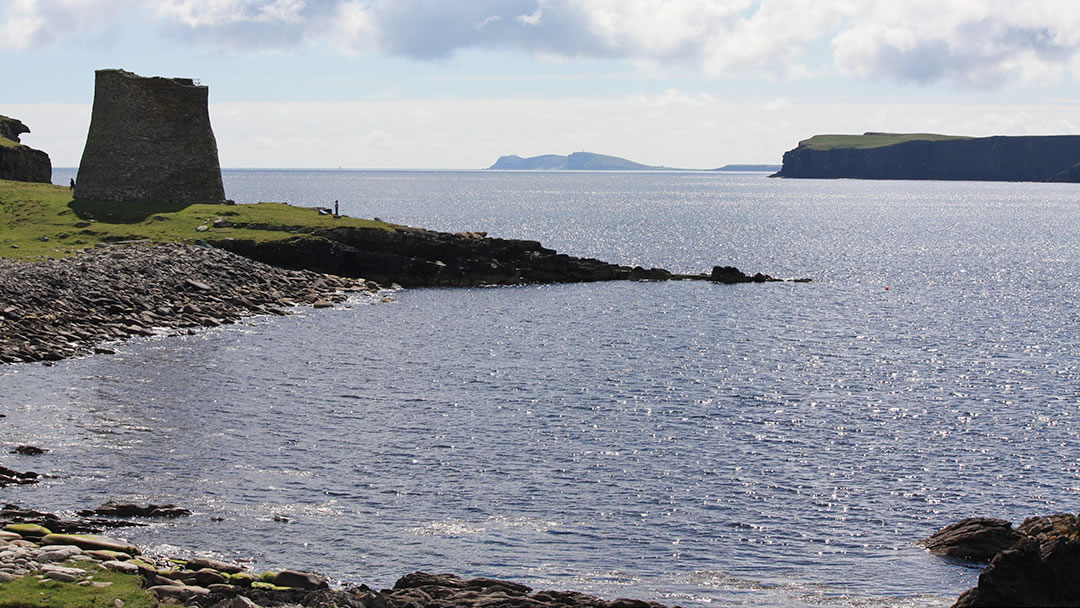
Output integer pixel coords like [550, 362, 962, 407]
[0, 0, 1080, 87]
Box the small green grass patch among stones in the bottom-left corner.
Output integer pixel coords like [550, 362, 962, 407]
[0, 562, 158, 608]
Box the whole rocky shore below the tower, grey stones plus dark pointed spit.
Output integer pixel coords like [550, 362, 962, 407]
[0, 236, 808, 364]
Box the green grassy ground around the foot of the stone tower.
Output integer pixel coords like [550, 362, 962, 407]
[0, 179, 394, 260]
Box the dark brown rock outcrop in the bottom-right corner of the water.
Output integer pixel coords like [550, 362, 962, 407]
[921, 513, 1080, 608]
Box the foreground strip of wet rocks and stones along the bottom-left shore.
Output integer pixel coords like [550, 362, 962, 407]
[0, 504, 663, 608]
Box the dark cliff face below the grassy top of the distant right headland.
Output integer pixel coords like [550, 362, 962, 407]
[775, 134, 1080, 183]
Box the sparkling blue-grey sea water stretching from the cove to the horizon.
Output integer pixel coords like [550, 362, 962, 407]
[12, 171, 1080, 606]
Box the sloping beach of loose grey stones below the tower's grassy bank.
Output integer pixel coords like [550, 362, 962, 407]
[0, 243, 380, 363]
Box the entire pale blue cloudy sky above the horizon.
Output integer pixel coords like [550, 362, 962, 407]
[6, 0, 1080, 168]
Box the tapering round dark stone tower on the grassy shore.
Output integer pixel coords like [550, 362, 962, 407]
[75, 69, 225, 203]
